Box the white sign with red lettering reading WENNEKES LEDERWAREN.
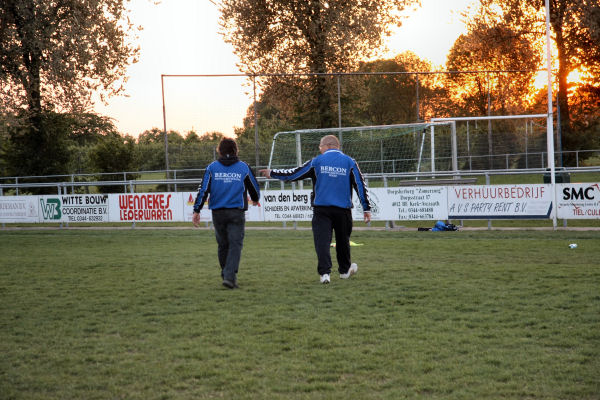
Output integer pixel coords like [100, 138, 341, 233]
[109, 192, 183, 222]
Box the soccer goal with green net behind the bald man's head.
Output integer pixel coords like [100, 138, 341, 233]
[269, 121, 457, 174]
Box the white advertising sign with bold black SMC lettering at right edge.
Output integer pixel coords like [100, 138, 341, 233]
[556, 183, 600, 219]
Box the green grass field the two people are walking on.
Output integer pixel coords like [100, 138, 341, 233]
[0, 229, 600, 400]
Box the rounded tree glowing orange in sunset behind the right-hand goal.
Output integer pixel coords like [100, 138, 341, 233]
[446, 17, 542, 169]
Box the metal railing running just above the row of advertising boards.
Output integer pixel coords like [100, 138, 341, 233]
[0, 150, 600, 195]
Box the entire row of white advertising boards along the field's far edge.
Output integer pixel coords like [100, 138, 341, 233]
[7, 183, 600, 223]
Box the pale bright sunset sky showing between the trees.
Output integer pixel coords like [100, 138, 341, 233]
[95, 0, 474, 137]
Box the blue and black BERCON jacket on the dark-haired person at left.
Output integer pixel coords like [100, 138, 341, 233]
[194, 156, 260, 212]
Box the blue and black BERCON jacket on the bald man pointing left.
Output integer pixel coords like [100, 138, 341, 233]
[271, 149, 371, 211]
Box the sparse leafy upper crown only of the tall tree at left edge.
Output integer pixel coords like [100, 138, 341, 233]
[0, 0, 138, 119]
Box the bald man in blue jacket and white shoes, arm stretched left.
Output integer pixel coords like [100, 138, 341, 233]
[259, 135, 371, 283]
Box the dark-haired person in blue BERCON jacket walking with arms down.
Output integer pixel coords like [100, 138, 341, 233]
[192, 138, 260, 289]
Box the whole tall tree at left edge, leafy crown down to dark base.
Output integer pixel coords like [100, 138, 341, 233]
[0, 0, 138, 175]
